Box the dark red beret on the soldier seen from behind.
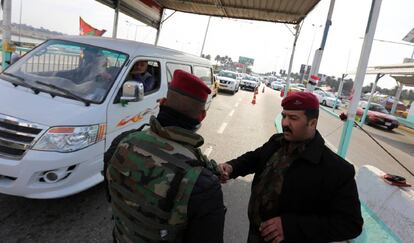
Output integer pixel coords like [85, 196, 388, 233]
[169, 69, 211, 102]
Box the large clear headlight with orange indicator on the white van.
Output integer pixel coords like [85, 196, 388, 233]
[33, 124, 106, 152]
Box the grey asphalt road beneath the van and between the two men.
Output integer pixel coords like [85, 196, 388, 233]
[0, 85, 414, 243]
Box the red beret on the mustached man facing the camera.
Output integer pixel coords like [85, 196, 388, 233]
[282, 92, 319, 110]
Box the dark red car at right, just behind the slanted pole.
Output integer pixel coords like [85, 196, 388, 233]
[356, 101, 400, 131]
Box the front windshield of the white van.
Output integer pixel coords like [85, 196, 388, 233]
[2, 40, 128, 103]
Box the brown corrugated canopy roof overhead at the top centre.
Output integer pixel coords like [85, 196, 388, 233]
[96, 0, 320, 27]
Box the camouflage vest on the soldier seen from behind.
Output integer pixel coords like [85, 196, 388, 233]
[107, 117, 222, 242]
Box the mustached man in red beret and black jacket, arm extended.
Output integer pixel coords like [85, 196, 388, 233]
[219, 92, 363, 243]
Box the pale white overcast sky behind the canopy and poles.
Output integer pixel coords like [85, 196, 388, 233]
[3, 0, 414, 88]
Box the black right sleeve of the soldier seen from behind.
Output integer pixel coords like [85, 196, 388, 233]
[184, 169, 225, 243]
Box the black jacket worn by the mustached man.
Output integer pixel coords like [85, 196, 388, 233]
[227, 132, 363, 242]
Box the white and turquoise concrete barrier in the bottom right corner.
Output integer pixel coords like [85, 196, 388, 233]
[354, 165, 414, 242]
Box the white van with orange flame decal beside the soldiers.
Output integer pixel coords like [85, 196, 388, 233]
[0, 36, 213, 198]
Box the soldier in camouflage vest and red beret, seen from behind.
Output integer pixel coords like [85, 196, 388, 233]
[106, 70, 225, 243]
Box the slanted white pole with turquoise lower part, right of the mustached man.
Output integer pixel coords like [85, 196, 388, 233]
[338, 0, 382, 158]
